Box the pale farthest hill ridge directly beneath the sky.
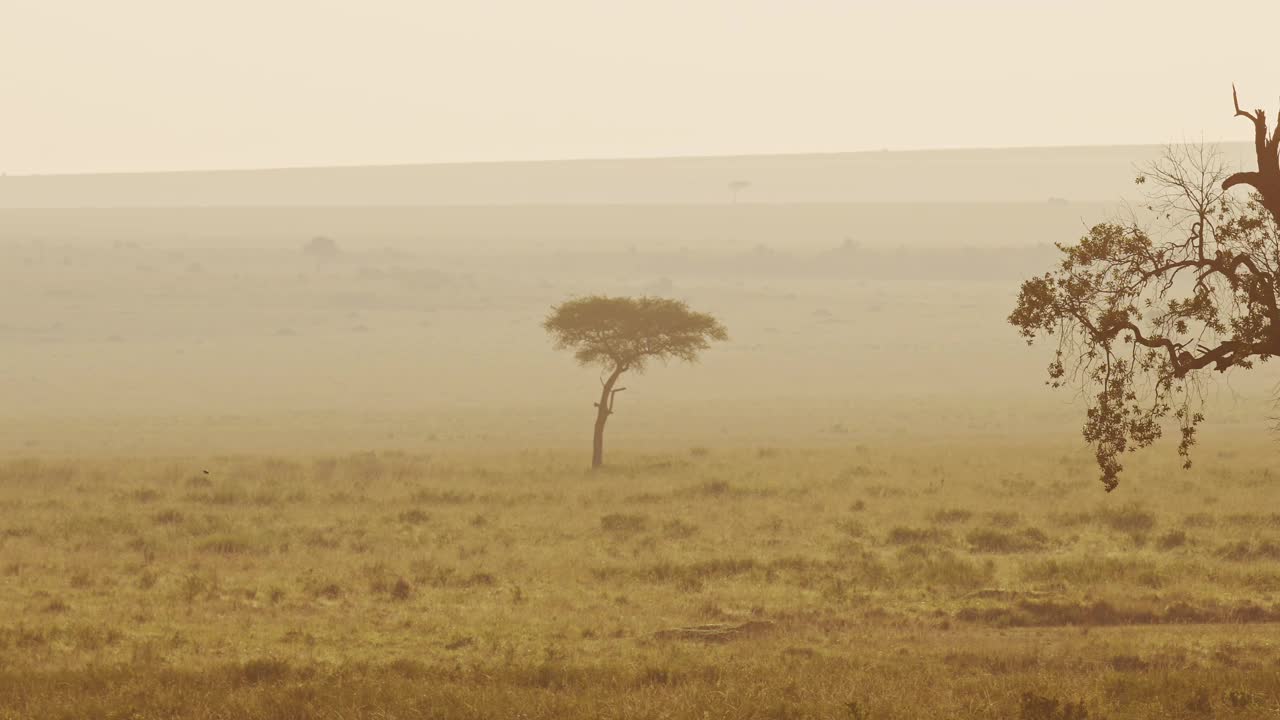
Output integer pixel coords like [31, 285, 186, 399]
[0, 143, 1252, 208]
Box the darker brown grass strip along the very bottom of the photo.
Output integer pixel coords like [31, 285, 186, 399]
[0, 633, 1280, 720]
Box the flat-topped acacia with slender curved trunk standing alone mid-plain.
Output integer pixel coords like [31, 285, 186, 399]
[543, 295, 728, 468]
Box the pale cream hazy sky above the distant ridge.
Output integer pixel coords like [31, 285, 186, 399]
[0, 0, 1280, 173]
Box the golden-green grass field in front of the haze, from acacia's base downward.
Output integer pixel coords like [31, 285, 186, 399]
[0, 445, 1280, 720]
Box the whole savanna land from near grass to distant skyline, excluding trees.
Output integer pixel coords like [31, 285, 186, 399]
[0, 149, 1280, 720]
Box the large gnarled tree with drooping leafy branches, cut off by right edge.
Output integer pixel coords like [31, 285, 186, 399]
[1009, 87, 1280, 492]
